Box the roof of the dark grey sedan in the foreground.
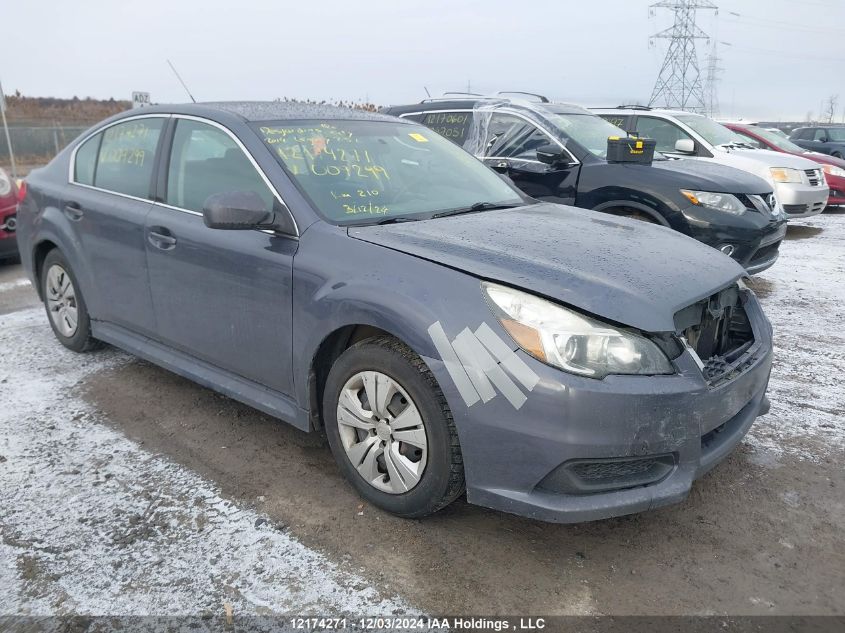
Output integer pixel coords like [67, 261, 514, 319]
[109, 101, 406, 123]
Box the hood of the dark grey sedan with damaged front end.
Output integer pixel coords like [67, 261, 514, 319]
[348, 203, 745, 332]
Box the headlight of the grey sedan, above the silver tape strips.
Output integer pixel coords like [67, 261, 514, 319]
[482, 282, 674, 378]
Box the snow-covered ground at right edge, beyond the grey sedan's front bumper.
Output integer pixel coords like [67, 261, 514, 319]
[747, 213, 845, 459]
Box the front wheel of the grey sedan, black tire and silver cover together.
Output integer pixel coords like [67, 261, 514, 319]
[323, 336, 465, 518]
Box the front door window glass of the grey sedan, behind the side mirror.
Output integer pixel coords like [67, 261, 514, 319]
[166, 119, 274, 212]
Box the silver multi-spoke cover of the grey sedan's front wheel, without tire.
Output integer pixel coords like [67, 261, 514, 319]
[337, 371, 428, 494]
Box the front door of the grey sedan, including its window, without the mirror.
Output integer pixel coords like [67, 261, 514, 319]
[146, 116, 299, 394]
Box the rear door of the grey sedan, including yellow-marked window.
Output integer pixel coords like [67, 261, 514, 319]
[67, 115, 169, 334]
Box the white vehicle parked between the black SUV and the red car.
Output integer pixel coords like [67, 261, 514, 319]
[593, 106, 830, 218]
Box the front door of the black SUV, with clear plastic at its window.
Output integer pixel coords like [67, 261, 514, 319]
[480, 112, 580, 204]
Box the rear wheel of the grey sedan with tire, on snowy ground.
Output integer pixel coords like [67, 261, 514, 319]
[40, 249, 101, 352]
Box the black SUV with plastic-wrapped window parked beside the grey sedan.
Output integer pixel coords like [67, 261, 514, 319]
[383, 96, 786, 274]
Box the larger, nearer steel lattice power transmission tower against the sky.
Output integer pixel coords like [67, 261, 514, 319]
[648, 0, 718, 112]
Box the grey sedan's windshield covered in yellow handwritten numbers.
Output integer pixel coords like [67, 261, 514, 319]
[254, 120, 524, 224]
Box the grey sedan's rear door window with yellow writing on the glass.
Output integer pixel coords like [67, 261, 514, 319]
[94, 117, 165, 198]
